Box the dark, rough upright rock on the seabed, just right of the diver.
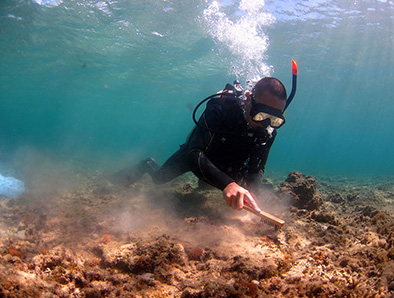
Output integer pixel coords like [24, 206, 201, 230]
[280, 172, 323, 210]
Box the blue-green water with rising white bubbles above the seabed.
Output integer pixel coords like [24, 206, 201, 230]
[0, 0, 394, 176]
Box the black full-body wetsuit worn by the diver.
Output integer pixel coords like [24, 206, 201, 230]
[147, 89, 276, 190]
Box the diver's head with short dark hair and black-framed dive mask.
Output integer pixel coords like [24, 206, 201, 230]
[245, 77, 287, 130]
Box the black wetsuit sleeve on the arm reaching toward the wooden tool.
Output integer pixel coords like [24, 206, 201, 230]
[187, 104, 234, 190]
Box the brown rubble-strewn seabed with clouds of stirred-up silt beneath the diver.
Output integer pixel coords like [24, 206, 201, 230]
[0, 173, 394, 297]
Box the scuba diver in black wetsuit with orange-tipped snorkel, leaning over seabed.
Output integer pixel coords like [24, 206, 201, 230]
[111, 60, 297, 212]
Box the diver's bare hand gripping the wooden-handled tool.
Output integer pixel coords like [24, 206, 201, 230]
[223, 182, 261, 212]
